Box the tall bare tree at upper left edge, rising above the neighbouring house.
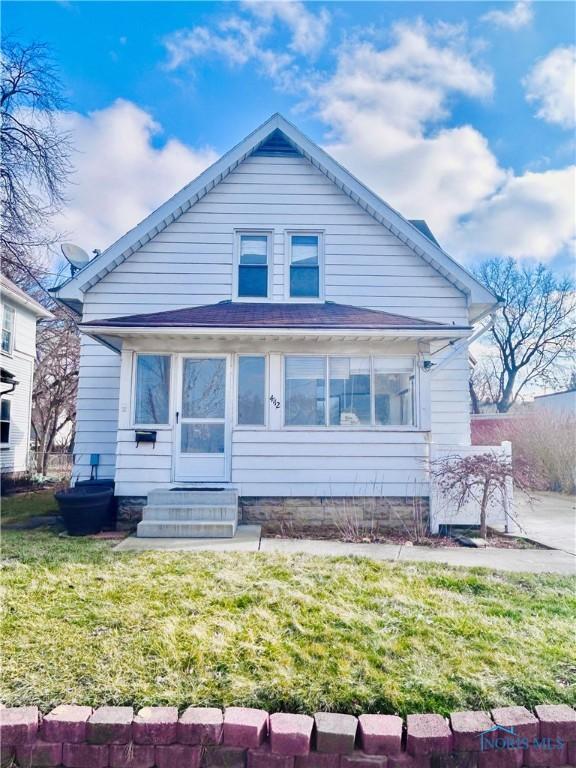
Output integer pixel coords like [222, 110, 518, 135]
[0, 39, 71, 294]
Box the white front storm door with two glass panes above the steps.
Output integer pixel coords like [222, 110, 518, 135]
[175, 355, 230, 482]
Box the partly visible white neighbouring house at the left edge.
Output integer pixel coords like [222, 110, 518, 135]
[0, 276, 52, 480]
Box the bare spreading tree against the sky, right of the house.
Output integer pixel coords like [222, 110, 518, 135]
[475, 258, 576, 413]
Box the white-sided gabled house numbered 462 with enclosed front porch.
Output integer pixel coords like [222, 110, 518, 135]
[55, 115, 498, 535]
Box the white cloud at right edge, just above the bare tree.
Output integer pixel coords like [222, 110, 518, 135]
[451, 166, 576, 261]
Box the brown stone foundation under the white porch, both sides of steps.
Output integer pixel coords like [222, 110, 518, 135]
[117, 496, 429, 538]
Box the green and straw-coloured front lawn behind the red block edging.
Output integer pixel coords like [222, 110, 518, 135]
[0, 530, 576, 714]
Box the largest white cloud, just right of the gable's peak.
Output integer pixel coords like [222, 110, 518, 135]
[311, 22, 504, 237]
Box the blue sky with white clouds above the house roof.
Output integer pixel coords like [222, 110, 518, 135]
[3, 0, 576, 271]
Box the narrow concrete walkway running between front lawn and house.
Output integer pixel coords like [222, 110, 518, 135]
[115, 525, 576, 574]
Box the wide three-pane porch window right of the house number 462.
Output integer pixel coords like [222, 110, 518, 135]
[284, 355, 415, 427]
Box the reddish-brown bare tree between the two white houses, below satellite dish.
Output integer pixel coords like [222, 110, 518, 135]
[32, 309, 80, 475]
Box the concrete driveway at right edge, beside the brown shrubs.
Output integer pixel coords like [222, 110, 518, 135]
[514, 493, 576, 555]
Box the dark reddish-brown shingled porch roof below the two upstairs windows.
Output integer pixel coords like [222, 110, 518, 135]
[80, 301, 468, 331]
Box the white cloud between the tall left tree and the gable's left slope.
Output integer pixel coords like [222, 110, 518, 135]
[53, 100, 216, 251]
